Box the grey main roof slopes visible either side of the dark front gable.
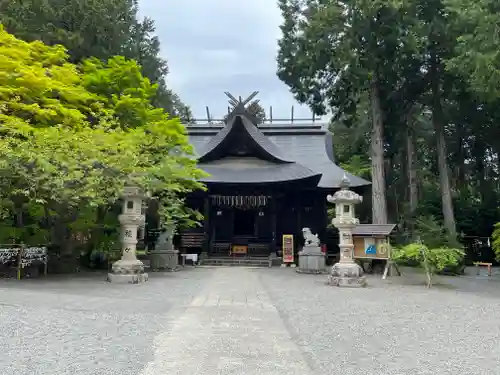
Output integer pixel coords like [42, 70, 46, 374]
[187, 123, 370, 188]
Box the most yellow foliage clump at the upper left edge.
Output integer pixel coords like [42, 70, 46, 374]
[0, 25, 97, 128]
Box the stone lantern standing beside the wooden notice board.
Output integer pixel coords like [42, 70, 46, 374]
[327, 175, 366, 287]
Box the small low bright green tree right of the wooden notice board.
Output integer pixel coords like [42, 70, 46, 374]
[391, 243, 465, 288]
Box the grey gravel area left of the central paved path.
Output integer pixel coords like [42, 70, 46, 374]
[0, 271, 205, 375]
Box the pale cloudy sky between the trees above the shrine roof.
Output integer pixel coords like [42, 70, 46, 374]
[140, 0, 311, 118]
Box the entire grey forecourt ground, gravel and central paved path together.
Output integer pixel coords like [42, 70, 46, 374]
[0, 268, 500, 375]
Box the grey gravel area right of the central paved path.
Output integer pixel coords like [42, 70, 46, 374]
[261, 270, 500, 375]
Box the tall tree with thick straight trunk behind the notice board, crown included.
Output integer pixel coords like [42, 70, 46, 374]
[278, 0, 422, 223]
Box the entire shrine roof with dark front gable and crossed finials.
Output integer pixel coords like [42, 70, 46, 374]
[187, 91, 370, 188]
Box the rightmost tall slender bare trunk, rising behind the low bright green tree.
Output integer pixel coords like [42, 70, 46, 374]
[431, 52, 457, 238]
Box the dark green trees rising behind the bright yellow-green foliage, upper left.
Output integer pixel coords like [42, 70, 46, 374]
[0, 0, 191, 118]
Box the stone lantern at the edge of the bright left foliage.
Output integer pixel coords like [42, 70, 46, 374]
[108, 186, 148, 284]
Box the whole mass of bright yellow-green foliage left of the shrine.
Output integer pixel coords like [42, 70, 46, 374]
[0, 30, 203, 250]
